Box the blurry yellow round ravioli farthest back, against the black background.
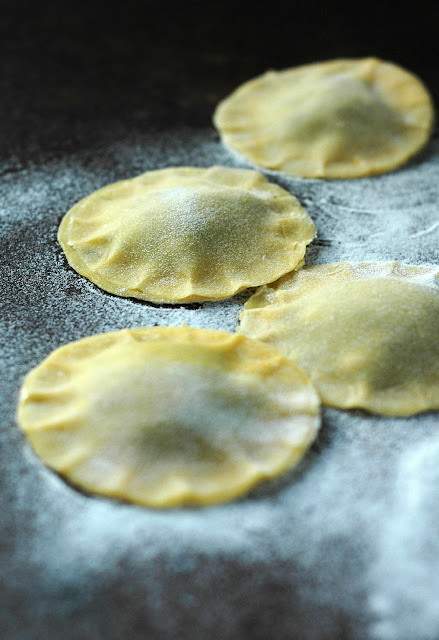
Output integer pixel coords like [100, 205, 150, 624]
[214, 58, 434, 178]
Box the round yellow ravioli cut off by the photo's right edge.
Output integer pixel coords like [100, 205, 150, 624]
[239, 262, 439, 416]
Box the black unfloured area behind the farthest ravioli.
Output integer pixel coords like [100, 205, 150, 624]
[0, 0, 439, 163]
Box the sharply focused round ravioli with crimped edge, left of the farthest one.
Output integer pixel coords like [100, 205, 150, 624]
[58, 167, 315, 303]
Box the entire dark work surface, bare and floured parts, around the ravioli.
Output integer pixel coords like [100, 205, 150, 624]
[0, 1, 439, 640]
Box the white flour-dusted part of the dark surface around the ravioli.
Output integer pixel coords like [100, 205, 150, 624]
[0, 129, 439, 640]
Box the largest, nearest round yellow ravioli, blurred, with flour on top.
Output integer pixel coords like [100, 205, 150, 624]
[17, 327, 320, 507]
